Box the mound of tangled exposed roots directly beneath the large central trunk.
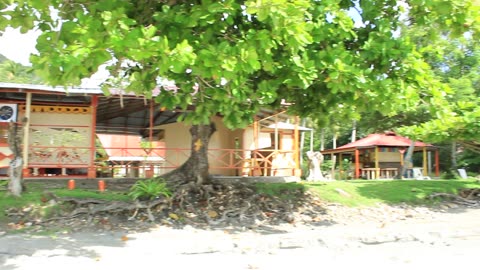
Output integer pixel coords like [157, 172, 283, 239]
[163, 179, 314, 226]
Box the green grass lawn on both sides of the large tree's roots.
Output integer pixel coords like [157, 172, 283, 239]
[0, 179, 480, 221]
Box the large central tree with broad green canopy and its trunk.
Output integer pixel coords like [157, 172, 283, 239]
[0, 0, 478, 183]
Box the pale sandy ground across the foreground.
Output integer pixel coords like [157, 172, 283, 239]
[0, 206, 480, 270]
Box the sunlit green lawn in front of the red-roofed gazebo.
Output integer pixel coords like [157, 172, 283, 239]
[305, 180, 480, 207]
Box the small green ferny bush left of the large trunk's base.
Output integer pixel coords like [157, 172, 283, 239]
[128, 178, 172, 200]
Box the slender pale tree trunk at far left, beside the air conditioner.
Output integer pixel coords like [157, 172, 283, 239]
[8, 119, 26, 197]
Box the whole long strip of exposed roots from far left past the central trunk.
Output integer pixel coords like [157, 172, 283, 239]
[3, 181, 325, 231]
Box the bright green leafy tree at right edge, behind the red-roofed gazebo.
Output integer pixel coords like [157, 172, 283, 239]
[404, 25, 480, 153]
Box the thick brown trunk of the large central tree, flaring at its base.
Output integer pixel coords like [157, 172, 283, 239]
[162, 123, 216, 185]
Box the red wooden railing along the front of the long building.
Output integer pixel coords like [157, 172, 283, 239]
[29, 146, 296, 177]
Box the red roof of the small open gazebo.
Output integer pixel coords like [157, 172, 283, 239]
[336, 132, 433, 149]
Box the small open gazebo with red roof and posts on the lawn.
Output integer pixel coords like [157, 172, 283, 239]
[321, 132, 440, 179]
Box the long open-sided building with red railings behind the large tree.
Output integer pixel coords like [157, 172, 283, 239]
[0, 83, 310, 178]
